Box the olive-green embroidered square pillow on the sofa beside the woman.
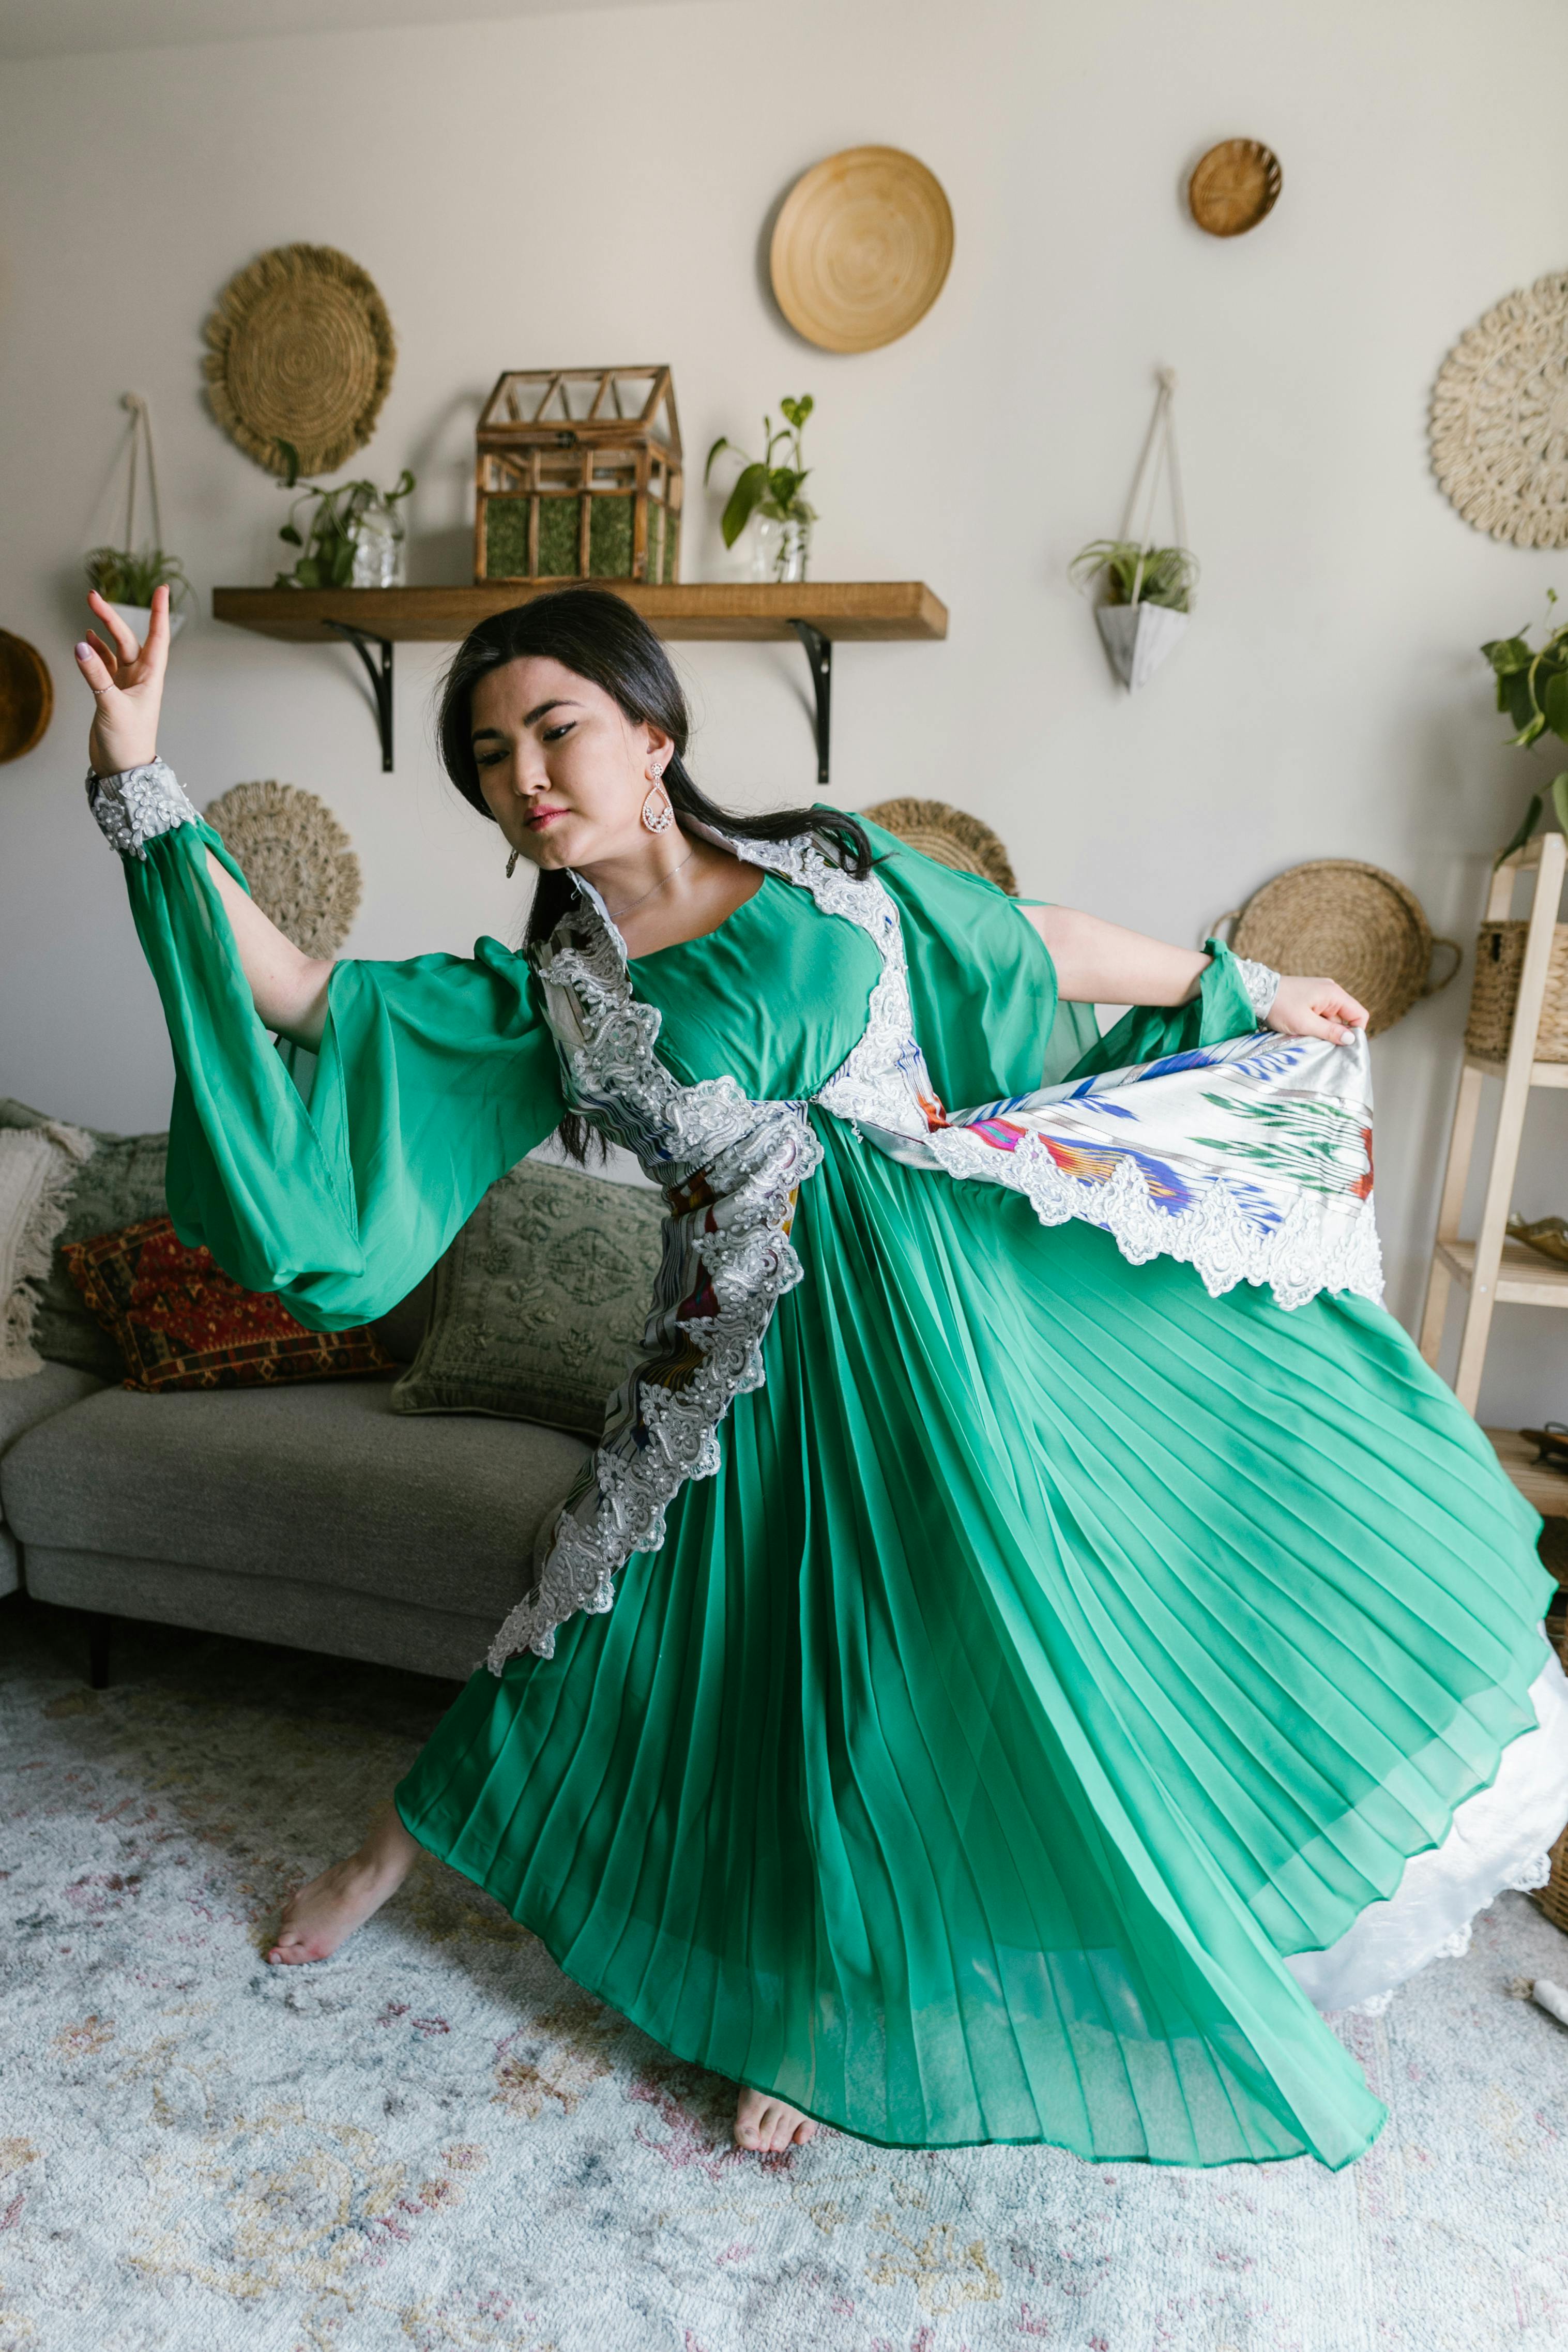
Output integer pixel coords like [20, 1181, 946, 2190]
[392, 1160, 663, 1437]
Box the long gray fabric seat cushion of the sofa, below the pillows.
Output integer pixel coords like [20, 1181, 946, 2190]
[0, 1380, 588, 1623]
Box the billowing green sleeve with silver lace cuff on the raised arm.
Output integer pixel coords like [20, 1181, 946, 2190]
[89, 762, 564, 1331]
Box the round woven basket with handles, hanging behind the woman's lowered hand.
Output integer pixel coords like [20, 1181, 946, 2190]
[1208, 858, 1465, 1037]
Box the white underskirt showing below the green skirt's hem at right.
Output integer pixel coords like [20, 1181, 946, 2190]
[1286, 1649, 1568, 2015]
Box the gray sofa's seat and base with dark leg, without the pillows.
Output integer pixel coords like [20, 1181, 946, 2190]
[0, 1294, 588, 1689]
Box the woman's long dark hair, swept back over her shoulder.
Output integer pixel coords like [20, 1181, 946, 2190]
[437, 588, 872, 1160]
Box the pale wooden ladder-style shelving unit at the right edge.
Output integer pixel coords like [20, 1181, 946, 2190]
[1420, 832, 1568, 1515]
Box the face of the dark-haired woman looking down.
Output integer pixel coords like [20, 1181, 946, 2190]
[470, 654, 673, 868]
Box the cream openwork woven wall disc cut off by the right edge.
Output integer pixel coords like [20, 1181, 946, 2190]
[1432, 273, 1568, 548]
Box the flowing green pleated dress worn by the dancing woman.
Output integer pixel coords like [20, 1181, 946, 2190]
[116, 785, 1568, 2166]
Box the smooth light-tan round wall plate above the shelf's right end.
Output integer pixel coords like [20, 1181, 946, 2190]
[769, 148, 952, 351]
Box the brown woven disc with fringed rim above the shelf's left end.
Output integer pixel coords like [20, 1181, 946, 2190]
[202, 245, 397, 475]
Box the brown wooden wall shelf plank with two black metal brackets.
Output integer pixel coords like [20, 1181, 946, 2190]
[211, 581, 948, 783]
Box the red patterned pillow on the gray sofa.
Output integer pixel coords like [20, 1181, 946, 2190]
[64, 1216, 392, 1390]
